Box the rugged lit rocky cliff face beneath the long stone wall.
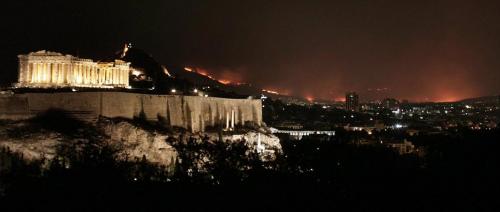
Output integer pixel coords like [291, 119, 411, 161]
[0, 118, 281, 167]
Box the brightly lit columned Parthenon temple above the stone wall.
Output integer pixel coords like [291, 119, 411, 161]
[15, 50, 130, 88]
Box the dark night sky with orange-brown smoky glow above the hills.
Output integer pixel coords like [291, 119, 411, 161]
[0, 0, 500, 101]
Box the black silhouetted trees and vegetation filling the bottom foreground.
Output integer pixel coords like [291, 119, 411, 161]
[0, 114, 500, 211]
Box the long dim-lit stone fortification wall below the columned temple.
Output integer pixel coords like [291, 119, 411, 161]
[0, 92, 262, 132]
